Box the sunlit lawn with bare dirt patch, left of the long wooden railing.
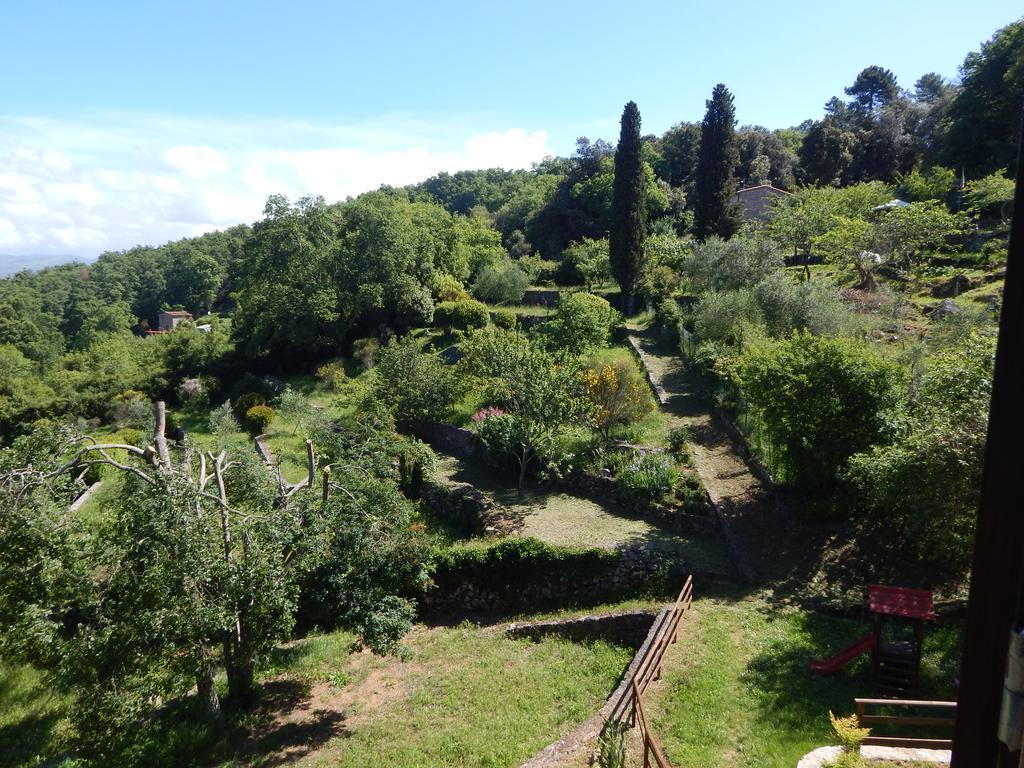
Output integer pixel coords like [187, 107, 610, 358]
[0, 625, 633, 768]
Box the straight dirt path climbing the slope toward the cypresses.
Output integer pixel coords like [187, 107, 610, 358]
[630, 331, 798, 582]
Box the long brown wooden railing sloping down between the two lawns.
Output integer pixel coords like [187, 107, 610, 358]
[608, 575, 693, 768]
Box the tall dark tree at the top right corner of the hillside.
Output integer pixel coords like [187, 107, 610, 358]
[941, 19, 1024, 177]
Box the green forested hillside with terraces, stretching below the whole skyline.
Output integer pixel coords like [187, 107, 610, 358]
[0, 19, 1024, 765]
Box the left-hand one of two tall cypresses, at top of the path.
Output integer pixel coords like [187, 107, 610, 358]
[608, 101, 647, 314]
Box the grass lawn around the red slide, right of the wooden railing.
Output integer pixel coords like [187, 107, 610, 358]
[647, 597, 956, 768]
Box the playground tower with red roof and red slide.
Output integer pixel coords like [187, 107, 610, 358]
[811, 584, 935, 694]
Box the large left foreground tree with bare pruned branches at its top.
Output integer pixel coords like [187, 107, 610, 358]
[0, 403, 422, 764]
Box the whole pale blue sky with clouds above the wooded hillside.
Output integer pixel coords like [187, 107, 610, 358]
[0, 0, 1022, 264]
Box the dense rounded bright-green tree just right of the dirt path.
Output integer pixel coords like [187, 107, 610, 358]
[739, 333, 898, 501]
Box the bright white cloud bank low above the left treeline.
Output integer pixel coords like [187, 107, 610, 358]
[0, 114, 550, 256]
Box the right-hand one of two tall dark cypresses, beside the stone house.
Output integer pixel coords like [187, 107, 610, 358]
[693, 83, 739, 240]
